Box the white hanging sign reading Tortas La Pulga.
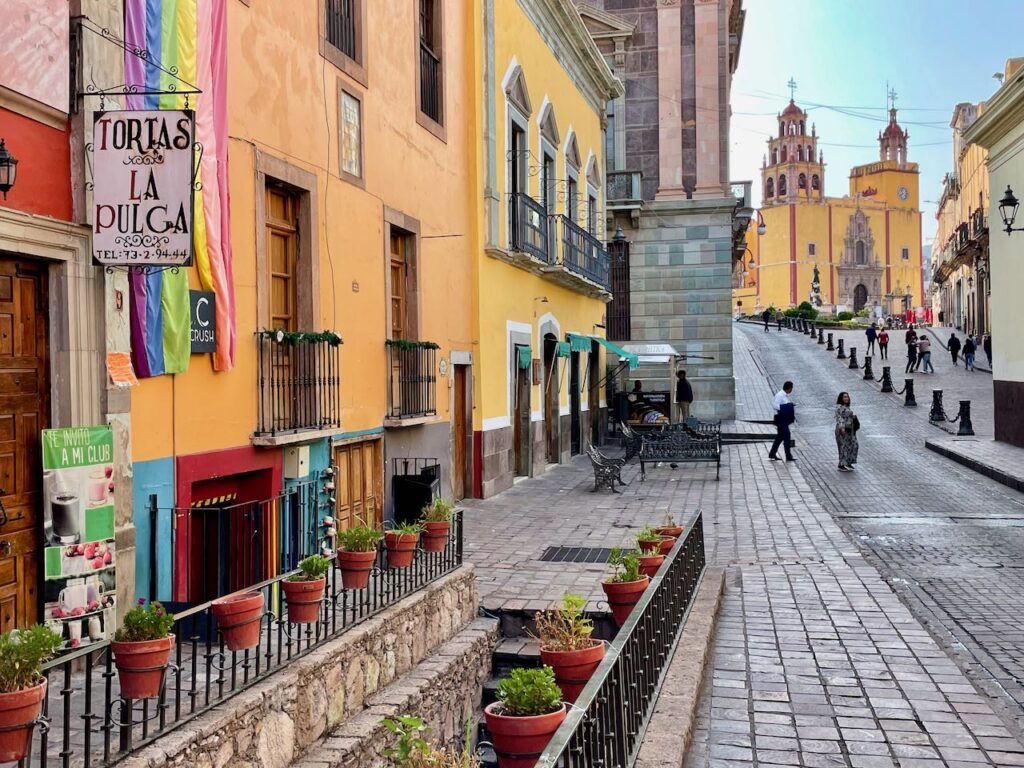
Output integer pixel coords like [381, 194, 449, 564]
[92, 110, 196, 266]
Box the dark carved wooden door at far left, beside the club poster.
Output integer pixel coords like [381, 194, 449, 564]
[0, 256, 49, 632]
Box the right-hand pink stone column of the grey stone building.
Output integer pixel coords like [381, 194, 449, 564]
[693, 0, 724, 198]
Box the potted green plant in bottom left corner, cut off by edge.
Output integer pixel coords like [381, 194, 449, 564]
[0, 624, 63, 763]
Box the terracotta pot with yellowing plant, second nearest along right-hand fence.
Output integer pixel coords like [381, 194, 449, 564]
[534, 595, 604, 703]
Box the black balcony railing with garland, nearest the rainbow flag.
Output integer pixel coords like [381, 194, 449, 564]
[256, 331, 341, 436]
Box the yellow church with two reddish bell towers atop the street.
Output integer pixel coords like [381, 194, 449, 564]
[733, 99, 924, 315]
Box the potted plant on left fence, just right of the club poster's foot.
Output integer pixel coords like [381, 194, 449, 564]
[111, 597, 174, 698]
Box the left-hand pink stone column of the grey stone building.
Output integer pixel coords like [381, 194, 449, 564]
[655, 0, 686, 200]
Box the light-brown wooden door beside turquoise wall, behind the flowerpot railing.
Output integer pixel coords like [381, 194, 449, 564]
[334, 440, 384, 530]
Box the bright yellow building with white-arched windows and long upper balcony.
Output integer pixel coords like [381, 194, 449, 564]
[469, 0, 622, 498]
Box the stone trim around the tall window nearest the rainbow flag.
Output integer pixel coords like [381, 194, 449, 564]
[256, 150, 321, 331]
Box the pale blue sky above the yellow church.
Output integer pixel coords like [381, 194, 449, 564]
[730, 0, 1024, 243]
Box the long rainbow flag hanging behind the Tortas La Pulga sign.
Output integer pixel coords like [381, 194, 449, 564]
[124, 0, 236, 377]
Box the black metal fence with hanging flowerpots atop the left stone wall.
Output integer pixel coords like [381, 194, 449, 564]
[23, 512, 463, 768]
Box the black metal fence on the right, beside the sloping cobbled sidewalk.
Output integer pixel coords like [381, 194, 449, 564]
[538, 512, 705, 768]
